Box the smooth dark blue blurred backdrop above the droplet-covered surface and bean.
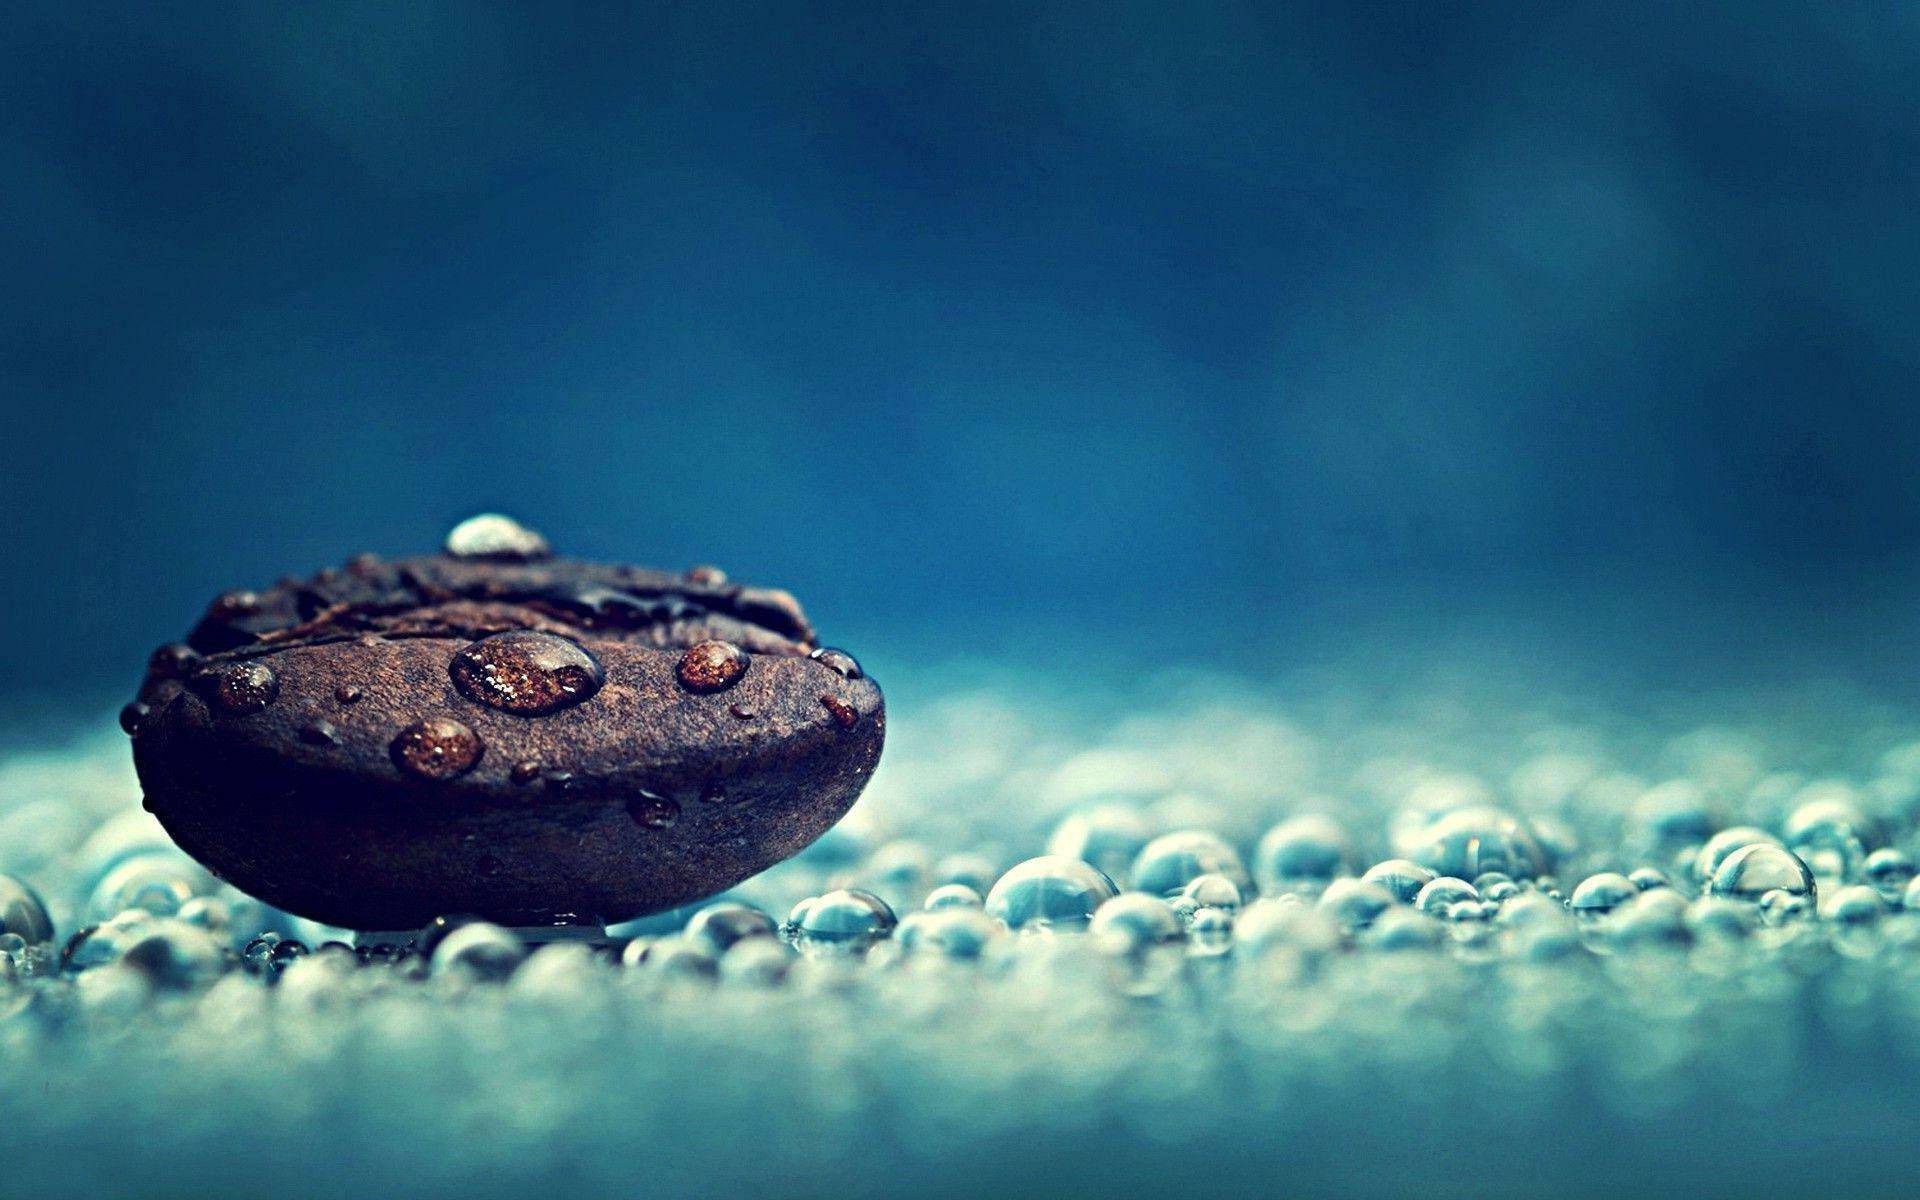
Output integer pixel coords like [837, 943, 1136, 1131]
[0, 4, 1920, 697]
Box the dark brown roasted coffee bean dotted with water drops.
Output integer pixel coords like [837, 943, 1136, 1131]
[125, 516, 885, 929]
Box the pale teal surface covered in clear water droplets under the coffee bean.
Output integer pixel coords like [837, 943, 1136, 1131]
[22, 637, 1920, 1196]
